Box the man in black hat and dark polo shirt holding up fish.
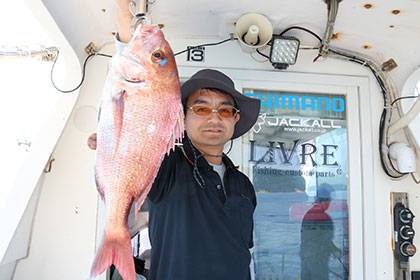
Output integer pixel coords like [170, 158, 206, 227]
[89, 0, 260, 280]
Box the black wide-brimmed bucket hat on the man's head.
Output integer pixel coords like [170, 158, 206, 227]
[181, 69, 260, 139]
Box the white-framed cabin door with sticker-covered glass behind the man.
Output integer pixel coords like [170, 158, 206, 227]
[177, 68, 368, 280]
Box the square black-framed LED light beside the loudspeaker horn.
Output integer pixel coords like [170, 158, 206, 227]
[270, 35, 300, 69]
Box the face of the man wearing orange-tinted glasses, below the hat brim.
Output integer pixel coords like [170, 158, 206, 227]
[185, 89, 239, 148]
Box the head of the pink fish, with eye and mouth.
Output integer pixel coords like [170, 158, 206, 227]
[124, 25, 178, 83]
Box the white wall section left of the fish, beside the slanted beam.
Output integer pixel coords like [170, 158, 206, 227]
[13, 47, 108, 280]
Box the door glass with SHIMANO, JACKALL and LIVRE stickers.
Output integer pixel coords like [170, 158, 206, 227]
[243, 88, 349, 280]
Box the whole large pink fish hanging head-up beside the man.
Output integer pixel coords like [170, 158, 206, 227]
[91, 25, 184, 280]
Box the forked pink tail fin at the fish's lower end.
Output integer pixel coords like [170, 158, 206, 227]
[90, 230, 136, 280]
